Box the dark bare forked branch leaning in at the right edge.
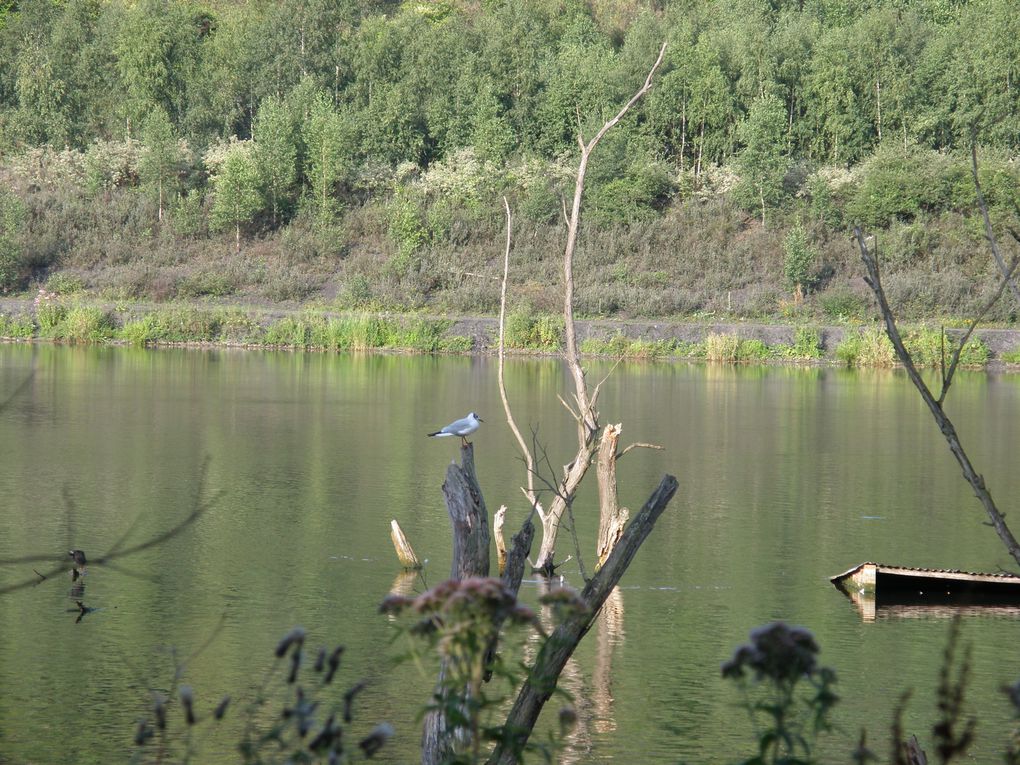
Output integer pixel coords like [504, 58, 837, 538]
[854, 144, 1020, 565]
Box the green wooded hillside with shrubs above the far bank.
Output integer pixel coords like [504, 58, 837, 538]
[0, 0, 1020, 319]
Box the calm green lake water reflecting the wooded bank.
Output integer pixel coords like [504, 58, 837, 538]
[0, 345, 1020, 764]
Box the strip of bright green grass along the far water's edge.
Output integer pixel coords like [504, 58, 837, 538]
[0, 296, 1003, 367]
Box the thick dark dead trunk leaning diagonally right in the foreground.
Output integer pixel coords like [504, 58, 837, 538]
[488, 475, 677, 765]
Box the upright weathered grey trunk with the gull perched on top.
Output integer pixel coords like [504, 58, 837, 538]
[421, 444, 489, 765]
